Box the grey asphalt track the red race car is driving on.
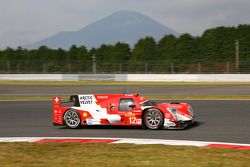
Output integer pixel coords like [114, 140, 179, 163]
[0, 100, 250, 144]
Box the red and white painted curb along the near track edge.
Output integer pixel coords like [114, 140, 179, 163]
[0, 137, 250, 150]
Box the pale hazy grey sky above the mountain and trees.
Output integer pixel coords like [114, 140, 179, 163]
[0, 0, 250, 49]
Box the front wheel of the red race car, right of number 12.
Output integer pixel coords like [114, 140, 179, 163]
[143, 108, 164, 130]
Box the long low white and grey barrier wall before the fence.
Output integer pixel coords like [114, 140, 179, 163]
[0, 74, 250, 82]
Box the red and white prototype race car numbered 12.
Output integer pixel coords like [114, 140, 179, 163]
[52, 94, 194, 129]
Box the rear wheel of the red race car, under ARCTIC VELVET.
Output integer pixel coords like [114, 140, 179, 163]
[63, 109, 81, 129]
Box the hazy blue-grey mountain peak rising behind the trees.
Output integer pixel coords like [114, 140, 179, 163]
[24, 11, 179, 49]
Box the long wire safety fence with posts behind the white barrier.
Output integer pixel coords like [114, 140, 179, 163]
[0, 60, 250, 74]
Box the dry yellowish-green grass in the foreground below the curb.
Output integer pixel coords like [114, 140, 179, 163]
[0, 143, 250, 167]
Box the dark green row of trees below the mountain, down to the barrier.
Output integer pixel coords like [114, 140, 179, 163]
[0, 25, 250, 73]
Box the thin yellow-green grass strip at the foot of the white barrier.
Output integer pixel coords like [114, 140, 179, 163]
[0, 81, 250, 86]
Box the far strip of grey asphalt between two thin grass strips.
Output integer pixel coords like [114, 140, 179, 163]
[0, 84, 250, 97]
